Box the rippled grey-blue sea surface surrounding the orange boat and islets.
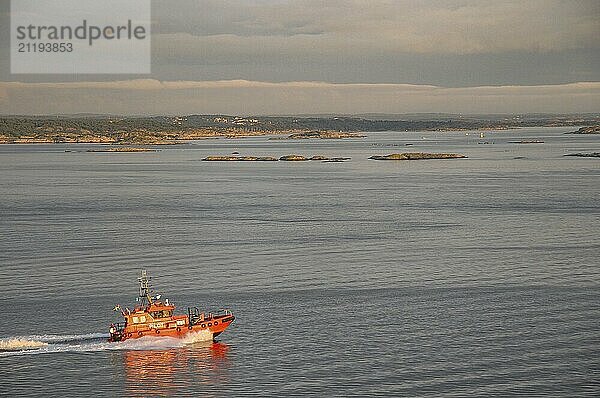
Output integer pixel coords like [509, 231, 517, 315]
[0, 128, 600, 397]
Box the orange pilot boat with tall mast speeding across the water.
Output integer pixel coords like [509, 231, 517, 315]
[108, 271, 235, 342]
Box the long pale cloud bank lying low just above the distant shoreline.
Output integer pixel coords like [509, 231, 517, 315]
[0, 79, 600, 115]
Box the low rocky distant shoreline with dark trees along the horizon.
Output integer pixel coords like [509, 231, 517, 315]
[0, 115, 600, 145]
